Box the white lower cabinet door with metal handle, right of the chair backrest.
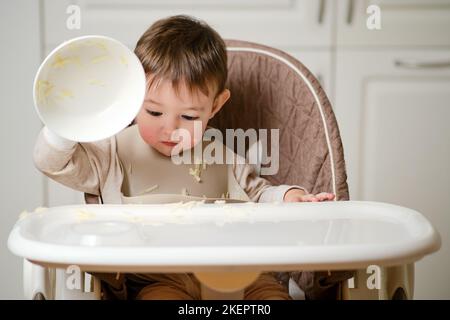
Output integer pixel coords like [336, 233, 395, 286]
[335, 51, 450, 299]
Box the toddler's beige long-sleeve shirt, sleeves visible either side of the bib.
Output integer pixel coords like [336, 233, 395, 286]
[33, 127, 306, 204]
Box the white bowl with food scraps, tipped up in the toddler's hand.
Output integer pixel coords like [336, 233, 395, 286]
[33, 36, 146, 142]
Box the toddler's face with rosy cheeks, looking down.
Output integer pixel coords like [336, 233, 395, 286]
[136, 80, 230, 156]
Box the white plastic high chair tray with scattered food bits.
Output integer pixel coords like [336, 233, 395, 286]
[8, 201, 441, 272]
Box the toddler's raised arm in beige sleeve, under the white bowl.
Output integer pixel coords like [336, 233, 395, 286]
[33, 127, 117, 195]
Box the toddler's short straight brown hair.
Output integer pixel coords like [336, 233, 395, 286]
[134, 15, 227, 95]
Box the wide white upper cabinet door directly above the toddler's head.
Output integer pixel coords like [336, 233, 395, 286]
[44, 0, 335, 49]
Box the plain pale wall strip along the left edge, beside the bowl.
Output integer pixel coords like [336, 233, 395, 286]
[0, 0, 44, 299]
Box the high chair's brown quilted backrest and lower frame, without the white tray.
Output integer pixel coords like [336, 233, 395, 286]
[9, 40, 440, 299]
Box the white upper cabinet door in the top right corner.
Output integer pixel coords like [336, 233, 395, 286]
[336, 0, 450, 47]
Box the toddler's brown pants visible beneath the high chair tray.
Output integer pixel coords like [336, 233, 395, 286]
[136, 273, 291, 300]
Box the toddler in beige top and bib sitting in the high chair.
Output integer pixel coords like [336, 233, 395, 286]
[34, 16, 334, 300]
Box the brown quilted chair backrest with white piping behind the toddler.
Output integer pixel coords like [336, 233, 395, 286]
[211, 40, 349, 200]
